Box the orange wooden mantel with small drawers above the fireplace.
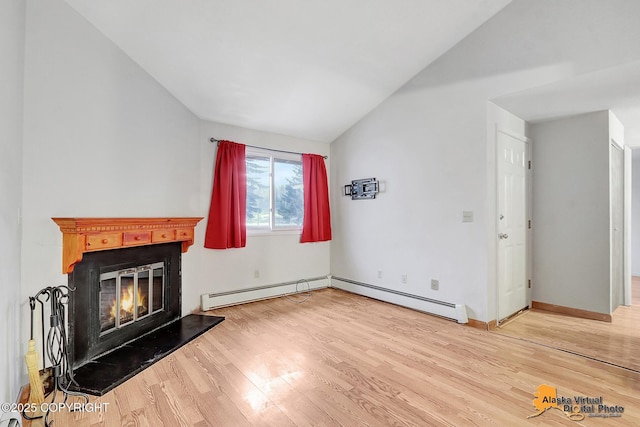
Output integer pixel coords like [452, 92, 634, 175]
[51, 217, 202, 274]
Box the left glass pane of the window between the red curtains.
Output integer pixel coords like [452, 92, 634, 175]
[246, 156, 269, 228]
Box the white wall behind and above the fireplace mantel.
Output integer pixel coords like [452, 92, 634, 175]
[22, 0, 202, 342]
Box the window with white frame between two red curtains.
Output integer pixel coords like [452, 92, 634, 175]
[246, 151, 304, 231]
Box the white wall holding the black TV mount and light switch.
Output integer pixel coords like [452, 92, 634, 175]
[331, 0, 640, 321]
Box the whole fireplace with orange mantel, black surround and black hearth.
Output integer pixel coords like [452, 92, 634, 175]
[53, 218, 224, 396]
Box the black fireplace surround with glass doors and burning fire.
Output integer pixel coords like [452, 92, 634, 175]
[69, 243, 182, 369]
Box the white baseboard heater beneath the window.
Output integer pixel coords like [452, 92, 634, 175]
[200, 276, 329, 311]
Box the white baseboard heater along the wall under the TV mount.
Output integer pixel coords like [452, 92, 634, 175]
[331, 276, 469, 323]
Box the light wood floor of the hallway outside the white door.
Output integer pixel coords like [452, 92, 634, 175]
[495, 277, 640, 372]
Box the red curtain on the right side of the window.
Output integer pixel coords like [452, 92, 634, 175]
[300, 154, 331, 243]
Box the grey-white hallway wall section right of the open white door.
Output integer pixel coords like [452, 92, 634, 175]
[532, 111, 611, 314]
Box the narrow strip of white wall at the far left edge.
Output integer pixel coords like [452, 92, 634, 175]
[0, 0, 29, 406]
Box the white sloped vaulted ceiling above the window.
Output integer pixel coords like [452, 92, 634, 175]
[61, 0, 510, 142]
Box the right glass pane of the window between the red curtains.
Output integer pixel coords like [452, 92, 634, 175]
[273, 159, 304, 228]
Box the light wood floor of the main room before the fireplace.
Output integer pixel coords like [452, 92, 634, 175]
[26, 289, 640, 427]
